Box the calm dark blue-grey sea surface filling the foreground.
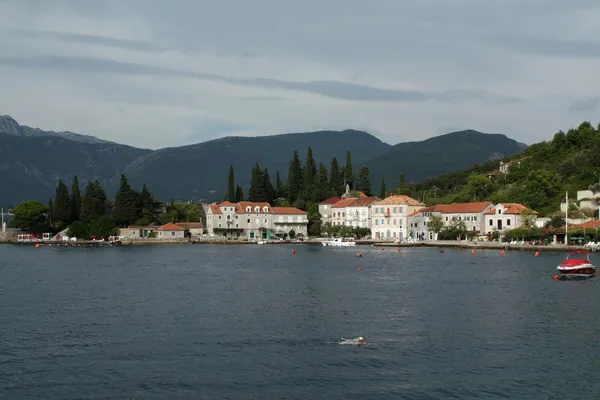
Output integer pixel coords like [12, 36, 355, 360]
[0, 245, 600, 400]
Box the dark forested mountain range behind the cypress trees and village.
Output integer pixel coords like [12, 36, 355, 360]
[0, 116, 526, 206]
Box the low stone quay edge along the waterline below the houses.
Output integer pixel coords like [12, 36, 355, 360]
[0, 239, 600, 253]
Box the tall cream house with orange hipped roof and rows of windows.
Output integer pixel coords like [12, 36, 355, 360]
[371, 195, 425, 240]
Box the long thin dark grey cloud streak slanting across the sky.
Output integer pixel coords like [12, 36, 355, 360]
[0, 56, 519, 102]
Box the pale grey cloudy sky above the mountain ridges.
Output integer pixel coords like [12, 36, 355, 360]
[0, 0, 600, 148]
